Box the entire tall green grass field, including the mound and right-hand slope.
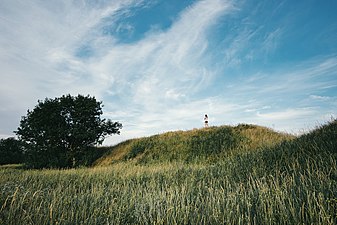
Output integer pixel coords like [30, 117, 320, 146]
[0, 121, 337, 225]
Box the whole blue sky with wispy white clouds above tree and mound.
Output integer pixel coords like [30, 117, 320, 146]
[0, 0, 337, 145]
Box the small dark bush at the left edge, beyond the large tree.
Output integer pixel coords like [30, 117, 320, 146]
[0, 137, 23, 165]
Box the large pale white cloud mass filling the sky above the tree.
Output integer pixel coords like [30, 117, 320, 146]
[0, 0, 148, 135]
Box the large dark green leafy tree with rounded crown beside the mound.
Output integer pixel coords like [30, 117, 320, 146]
[15, 95, 122, 168]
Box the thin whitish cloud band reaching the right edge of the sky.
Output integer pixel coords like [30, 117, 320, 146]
[235, 56, 337, 97]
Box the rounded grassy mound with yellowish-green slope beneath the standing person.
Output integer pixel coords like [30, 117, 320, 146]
[94, 124, 295, 166]
